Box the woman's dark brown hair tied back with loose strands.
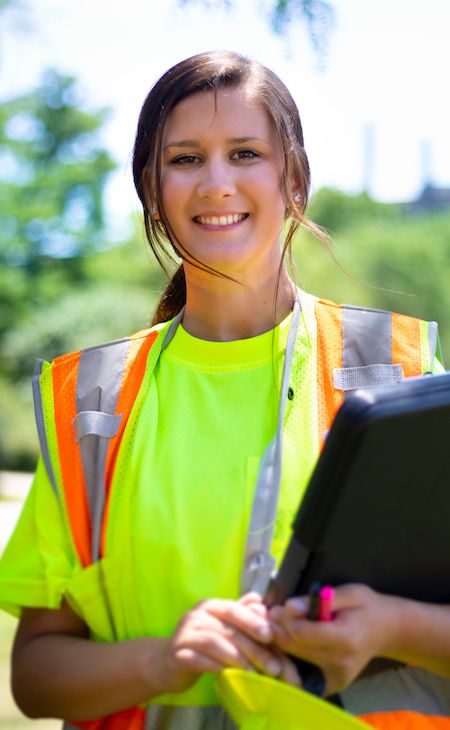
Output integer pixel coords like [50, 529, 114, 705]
[133, 51, 326, 324]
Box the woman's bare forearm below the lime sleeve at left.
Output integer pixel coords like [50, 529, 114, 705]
[12, 634, 167, 722]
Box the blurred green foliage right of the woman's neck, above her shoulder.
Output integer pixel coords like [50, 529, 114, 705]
[294, 191, 450, 363]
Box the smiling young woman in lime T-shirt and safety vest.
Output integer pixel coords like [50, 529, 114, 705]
[0, 52, 450, 730]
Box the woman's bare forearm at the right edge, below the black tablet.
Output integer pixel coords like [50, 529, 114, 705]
[384, 598, 450, 676]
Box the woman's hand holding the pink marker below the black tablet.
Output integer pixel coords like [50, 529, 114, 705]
[269, 584, 401, 694]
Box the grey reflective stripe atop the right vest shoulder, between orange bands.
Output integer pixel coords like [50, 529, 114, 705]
[342, 304, 392, 368]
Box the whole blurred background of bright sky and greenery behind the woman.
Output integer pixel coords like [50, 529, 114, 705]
[0, 0, 450, 730]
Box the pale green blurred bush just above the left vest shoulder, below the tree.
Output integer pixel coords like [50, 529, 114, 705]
[3, 241, 161, 381]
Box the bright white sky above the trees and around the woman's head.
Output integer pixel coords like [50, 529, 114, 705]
[0, 0, 450, 235]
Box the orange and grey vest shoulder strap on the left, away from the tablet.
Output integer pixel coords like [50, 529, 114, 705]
[33, 323, 166, 566]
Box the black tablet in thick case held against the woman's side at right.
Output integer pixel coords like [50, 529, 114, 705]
[265, 373, 450, 605]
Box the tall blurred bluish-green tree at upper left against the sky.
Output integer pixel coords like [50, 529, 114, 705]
[0, 71, 115, 276]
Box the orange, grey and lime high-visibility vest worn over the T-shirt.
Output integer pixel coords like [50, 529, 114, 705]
[33, 292, 442, 730]
